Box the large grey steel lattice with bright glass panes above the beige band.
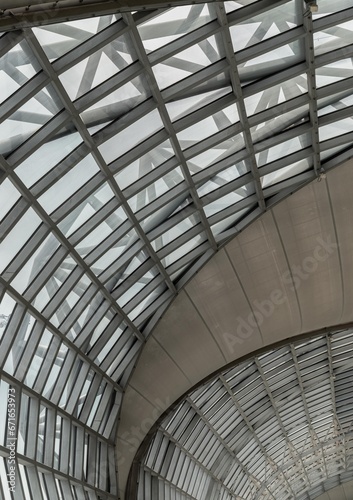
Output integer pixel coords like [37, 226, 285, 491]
[0, 0, 353, 500]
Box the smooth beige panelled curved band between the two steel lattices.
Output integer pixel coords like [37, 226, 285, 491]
[117, 161, 353, 498]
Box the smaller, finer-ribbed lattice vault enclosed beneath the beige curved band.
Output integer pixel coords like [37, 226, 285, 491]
[137, 330, 353, 500]
